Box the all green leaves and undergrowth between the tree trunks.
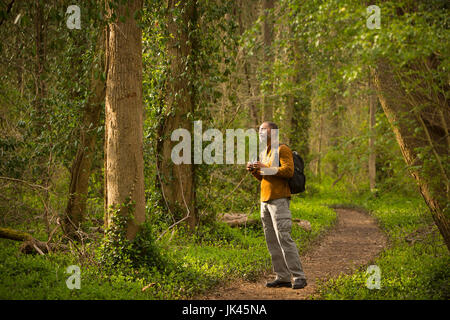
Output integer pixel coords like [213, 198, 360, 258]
[0, 0, 450, 299]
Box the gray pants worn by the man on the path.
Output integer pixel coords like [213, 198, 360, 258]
[261, 198, 306, 281]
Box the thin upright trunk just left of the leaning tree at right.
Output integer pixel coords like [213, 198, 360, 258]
[369, 71, 377, 192]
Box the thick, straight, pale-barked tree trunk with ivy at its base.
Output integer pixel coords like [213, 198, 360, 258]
[105, 0, 145, 239]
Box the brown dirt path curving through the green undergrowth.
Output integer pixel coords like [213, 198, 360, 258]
[196, 209, 387, 300]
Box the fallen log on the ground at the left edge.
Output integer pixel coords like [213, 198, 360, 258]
[0, 227, 69, 255]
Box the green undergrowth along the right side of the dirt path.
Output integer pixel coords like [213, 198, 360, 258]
[318, 189, 450, 300]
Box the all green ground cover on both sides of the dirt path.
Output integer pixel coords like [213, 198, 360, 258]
[0, 182, 450, 299]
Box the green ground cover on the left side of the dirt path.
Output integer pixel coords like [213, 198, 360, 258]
[0, 189, 336, 299]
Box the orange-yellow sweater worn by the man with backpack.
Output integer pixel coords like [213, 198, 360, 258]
[252, 144, 294, 201]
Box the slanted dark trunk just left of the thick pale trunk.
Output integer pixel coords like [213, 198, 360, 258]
[63, 31, 106, 237]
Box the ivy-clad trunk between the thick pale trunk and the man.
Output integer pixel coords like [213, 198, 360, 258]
[157, 0, 197, 230]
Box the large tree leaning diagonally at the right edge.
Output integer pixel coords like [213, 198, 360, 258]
[374, 58, 450, 250]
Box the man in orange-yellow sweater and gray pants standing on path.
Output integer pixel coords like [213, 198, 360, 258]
[247, 121, 306, 289]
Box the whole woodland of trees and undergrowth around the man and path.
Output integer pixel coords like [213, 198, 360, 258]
[0, 0, 450, 299]
